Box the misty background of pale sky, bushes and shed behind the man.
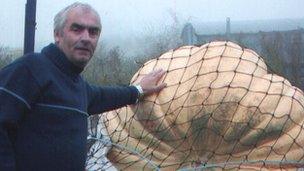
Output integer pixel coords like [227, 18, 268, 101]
[0, 0, 304, 87]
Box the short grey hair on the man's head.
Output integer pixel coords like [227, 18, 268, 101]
[54, 2, 101, 33]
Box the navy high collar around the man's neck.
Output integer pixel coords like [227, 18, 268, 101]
[41, 43, 83, 77]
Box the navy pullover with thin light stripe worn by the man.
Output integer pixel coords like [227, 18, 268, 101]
[0, 44, 138, 171]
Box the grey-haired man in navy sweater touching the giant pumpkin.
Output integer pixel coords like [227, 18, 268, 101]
[0, 3, 165, 171]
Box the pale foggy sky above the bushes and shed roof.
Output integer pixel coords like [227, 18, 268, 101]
[0, 0, 304, 49]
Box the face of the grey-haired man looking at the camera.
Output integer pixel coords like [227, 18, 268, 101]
[55, 8, 101, 68]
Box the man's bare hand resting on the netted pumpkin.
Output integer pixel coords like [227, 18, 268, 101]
[139, 69, 167, 95]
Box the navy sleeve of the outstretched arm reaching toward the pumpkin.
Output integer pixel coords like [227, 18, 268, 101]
[87, 84, 139, 115]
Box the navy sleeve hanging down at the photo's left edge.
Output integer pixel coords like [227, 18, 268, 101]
[0, 62, 38, 170]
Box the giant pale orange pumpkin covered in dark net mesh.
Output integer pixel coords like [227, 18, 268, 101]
[87, 41, 304, 170]
